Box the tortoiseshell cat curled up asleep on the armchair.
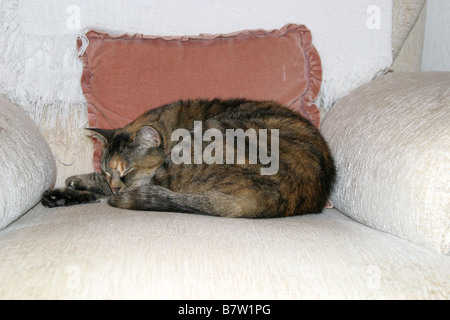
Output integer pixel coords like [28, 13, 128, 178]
[42, 99, 336, 218]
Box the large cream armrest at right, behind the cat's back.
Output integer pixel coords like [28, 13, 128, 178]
[322, 72, 450, 254]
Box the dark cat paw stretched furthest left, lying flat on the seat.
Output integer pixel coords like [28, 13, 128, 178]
[41, 188, 98, 208]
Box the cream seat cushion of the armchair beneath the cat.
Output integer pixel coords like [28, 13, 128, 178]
[0, 204, 450, 299]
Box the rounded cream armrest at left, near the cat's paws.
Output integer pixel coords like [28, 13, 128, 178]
[0, 96, 56, 229]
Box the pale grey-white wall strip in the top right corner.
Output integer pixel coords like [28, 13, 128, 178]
[422, 0, 450, 71]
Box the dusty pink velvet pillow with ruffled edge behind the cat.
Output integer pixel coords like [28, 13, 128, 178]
[78, 24, 322, 169]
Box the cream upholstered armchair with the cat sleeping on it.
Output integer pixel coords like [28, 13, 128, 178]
[0, 1, 450, 299]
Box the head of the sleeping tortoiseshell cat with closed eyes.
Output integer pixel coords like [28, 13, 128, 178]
[88, 126, 164, 193]
